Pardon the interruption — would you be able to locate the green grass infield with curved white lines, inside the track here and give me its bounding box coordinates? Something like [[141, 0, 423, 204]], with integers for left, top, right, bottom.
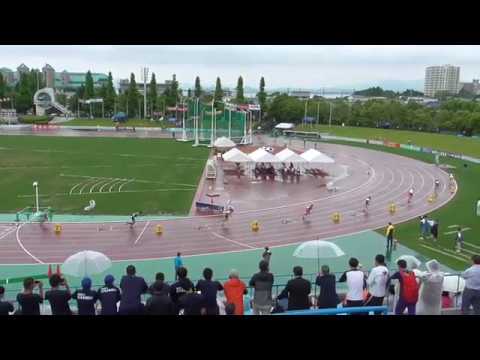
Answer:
[[0, 136, 209, 215]]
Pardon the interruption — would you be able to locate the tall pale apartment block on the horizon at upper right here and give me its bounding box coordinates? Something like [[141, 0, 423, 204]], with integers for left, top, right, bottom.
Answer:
[[424, 65, 460, 98]]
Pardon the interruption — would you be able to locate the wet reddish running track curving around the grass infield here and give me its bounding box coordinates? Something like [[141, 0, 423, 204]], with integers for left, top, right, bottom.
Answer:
[[0, 144, 454, 264]]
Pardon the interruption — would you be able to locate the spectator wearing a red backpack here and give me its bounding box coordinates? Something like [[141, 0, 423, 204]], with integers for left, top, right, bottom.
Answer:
[[387, 260, 420, 315]]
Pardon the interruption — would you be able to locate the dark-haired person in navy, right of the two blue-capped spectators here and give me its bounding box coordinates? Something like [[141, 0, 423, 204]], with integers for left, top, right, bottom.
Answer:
[[119, 265, 148, 315]]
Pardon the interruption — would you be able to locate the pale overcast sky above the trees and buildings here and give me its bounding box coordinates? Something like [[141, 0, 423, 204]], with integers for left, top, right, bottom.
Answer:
[[0, 45, 480, 88]]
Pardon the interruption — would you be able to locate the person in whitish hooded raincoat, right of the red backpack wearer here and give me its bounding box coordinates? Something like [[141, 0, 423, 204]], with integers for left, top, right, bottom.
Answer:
[[416, 260, 444, 315]]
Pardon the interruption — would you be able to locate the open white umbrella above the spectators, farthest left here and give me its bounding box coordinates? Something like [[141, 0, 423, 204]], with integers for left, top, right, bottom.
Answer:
[[62, 250, 112, 277]]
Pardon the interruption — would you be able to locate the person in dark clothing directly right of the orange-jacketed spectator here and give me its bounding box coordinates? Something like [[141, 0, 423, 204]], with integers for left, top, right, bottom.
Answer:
[[249, 260, 274, 315]]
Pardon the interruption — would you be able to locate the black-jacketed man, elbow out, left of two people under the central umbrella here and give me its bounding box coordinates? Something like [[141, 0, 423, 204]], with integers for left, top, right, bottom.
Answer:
[[277, 266, 312, 310]]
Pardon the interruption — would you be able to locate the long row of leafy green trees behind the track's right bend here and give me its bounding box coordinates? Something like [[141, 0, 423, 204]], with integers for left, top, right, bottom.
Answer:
[[264, 94, 480, 132]]
